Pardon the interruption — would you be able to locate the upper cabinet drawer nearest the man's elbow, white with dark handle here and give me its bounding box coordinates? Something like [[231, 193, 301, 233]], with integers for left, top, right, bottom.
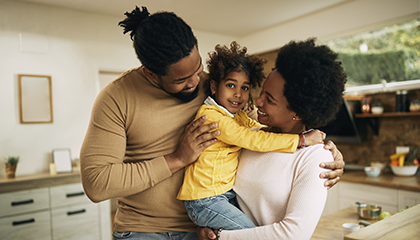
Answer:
[[50, 183, 90, 208]]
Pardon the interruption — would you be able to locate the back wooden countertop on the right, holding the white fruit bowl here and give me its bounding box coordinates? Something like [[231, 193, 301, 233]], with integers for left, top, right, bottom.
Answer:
[[341, 170, 420, 192]]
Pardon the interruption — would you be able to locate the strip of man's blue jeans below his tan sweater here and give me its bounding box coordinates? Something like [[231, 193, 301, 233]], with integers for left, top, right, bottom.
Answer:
[[112, 231, 198, 240]]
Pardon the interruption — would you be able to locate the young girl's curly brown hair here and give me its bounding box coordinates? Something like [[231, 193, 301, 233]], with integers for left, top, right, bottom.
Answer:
[[204, 41, 267, 109]]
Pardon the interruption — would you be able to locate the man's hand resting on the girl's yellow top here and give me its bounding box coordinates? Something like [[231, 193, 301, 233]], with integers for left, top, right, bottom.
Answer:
[[165, 116, 220, 173]]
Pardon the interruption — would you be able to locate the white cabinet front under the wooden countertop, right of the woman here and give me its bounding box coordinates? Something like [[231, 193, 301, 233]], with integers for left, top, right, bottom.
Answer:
[[339, 182, 398, 206]]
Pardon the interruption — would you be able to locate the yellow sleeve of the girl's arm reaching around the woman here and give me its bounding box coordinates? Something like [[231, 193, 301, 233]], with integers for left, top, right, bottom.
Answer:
[[201, 107, 299, 152]]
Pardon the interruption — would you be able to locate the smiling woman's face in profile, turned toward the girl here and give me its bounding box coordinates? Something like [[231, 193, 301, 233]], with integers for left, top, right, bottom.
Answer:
[[255, 70, 302, 133]]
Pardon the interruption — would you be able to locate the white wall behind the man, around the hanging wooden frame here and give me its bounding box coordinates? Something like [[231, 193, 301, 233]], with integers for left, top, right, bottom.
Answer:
[[0, 1, 235, 177]]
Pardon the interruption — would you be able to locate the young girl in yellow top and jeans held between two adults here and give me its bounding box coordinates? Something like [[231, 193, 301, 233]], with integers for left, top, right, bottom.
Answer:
[[177, 42, 325, 230]]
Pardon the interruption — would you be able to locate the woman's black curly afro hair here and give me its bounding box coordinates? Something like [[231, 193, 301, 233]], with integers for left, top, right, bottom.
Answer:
[[275, 38, 347, 127]]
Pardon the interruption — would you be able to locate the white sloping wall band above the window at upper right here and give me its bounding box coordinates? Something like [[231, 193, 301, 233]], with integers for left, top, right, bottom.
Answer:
[[240, 0, 420, 53]]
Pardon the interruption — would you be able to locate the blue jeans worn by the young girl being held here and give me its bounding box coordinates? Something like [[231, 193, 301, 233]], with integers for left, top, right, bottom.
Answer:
[[184, 190, 255, 230]]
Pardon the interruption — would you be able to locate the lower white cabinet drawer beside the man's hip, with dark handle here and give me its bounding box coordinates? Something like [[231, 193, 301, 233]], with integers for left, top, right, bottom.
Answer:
[[52, 203, 100, 240]]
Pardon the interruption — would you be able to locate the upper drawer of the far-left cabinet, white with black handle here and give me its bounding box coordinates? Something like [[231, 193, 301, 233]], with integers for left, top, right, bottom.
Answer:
[[0, 188, 50, 217]]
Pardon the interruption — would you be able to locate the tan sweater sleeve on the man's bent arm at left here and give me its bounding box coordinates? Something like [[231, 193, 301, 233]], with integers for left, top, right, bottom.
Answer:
[[80, 86, 172, 202]]
